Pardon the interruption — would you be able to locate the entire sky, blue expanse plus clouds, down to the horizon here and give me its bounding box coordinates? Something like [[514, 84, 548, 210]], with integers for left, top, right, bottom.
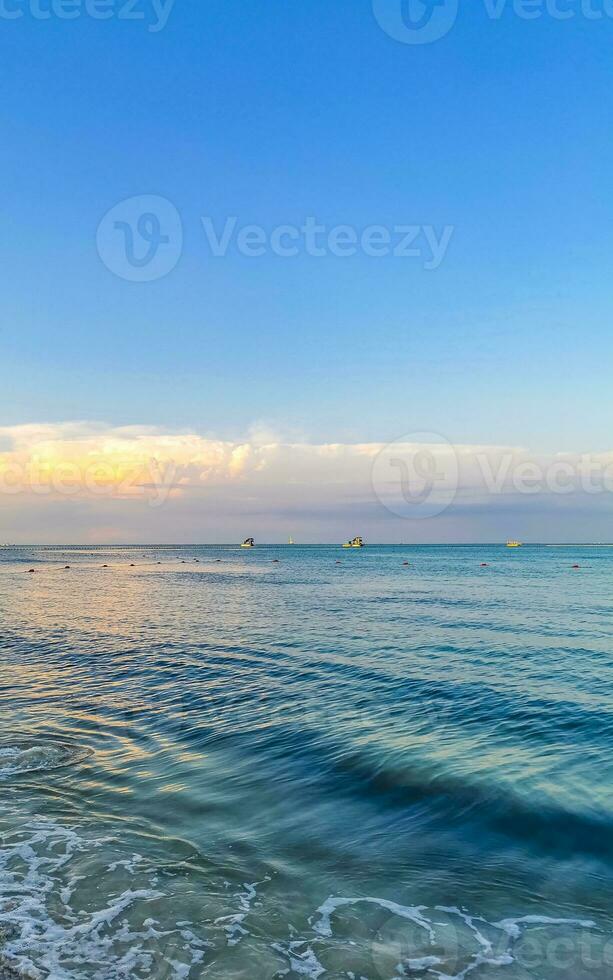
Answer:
[[0, 0, 613, 542]]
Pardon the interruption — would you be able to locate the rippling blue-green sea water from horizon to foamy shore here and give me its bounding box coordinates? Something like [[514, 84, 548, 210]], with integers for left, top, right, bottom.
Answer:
[[0, 546, 613, 980]]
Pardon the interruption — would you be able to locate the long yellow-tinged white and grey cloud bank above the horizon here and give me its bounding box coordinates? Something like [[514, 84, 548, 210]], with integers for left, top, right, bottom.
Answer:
[[0, 421, 613, 544]]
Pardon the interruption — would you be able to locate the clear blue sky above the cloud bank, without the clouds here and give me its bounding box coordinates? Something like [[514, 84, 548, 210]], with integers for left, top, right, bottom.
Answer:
[[0, 0, 613, 451]]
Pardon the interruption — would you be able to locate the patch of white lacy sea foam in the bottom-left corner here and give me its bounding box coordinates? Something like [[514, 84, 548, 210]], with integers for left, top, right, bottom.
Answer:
[[0, 818, 209, 980]]
